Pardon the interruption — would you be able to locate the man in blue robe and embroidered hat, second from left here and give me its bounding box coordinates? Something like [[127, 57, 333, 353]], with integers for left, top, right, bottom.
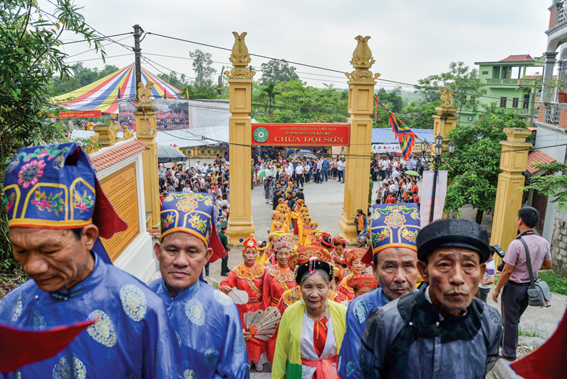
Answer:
[[149, 193, 250, 379]]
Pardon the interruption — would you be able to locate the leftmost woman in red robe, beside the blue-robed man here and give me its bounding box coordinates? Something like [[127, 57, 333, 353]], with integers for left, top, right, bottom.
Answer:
[[219, 234, 266, 371]]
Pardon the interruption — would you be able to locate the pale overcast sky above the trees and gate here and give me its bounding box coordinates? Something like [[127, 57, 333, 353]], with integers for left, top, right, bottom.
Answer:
[[51, 0, 551, 89]]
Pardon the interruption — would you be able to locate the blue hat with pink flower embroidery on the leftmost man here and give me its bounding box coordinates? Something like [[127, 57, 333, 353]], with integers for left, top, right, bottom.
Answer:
[[4, 142, 128, 262]]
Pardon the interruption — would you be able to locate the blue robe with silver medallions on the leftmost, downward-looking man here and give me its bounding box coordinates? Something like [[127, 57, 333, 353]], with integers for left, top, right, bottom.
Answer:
[[0, 254, 179, 379]]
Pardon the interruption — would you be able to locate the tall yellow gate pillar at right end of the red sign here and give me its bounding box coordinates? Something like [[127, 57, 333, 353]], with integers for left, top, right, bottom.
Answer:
[[339, 36, 380, 243]]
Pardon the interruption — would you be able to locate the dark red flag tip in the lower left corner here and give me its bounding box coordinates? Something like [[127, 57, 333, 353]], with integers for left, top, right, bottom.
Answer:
[[0, 319, 98, 372]]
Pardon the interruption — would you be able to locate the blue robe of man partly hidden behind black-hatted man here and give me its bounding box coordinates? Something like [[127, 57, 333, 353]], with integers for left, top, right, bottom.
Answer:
[[339, 287, 388, 379]]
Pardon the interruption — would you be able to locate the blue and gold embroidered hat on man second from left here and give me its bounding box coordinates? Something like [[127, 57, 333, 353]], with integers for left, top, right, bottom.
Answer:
[[161, 192, 227, 262]]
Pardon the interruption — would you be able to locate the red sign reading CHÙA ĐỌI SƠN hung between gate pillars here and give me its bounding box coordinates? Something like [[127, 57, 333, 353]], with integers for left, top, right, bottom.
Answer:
[[252, 123, 350, 146]]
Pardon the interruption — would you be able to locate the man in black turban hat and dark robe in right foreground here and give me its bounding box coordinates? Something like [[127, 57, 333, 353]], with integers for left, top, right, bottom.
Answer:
[[358, 219, 502, 379]]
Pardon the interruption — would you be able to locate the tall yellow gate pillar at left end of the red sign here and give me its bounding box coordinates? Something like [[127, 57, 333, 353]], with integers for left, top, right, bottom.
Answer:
[[225, 32, 255, 245]]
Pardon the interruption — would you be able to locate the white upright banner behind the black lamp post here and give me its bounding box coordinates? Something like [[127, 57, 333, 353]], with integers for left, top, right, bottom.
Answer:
[[419, 170, 447, 228]]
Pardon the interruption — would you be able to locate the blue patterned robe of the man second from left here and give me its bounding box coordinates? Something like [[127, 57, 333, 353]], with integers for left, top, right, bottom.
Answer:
[[149, 279, 250, 379]]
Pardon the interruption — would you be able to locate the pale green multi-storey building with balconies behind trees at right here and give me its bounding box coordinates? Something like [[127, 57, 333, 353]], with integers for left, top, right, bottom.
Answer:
[[458, 54, 544, 124]]
